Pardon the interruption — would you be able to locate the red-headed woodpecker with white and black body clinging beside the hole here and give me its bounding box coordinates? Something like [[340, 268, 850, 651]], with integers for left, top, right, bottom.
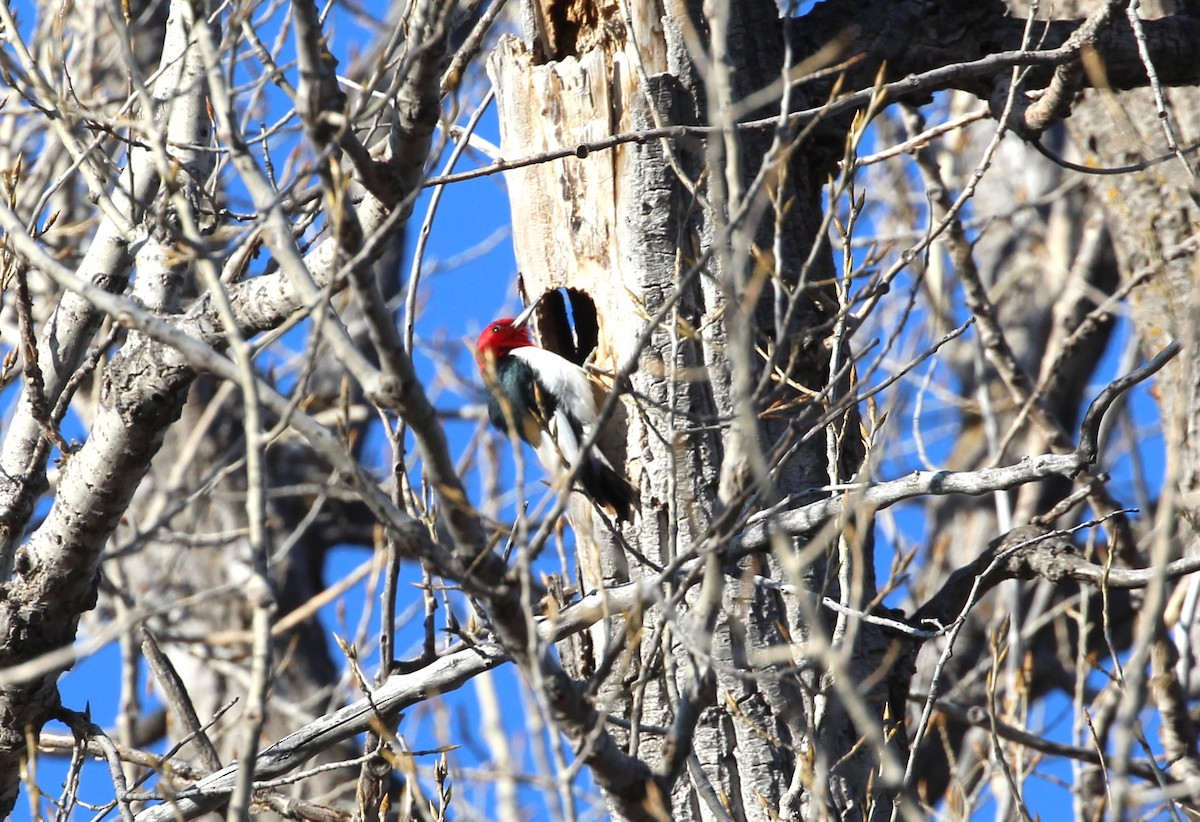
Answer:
[[475, 301, 637, 521]]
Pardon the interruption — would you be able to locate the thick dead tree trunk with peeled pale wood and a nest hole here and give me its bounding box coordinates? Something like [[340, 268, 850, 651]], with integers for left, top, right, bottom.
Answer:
[[491, 2, 895, 820]]
